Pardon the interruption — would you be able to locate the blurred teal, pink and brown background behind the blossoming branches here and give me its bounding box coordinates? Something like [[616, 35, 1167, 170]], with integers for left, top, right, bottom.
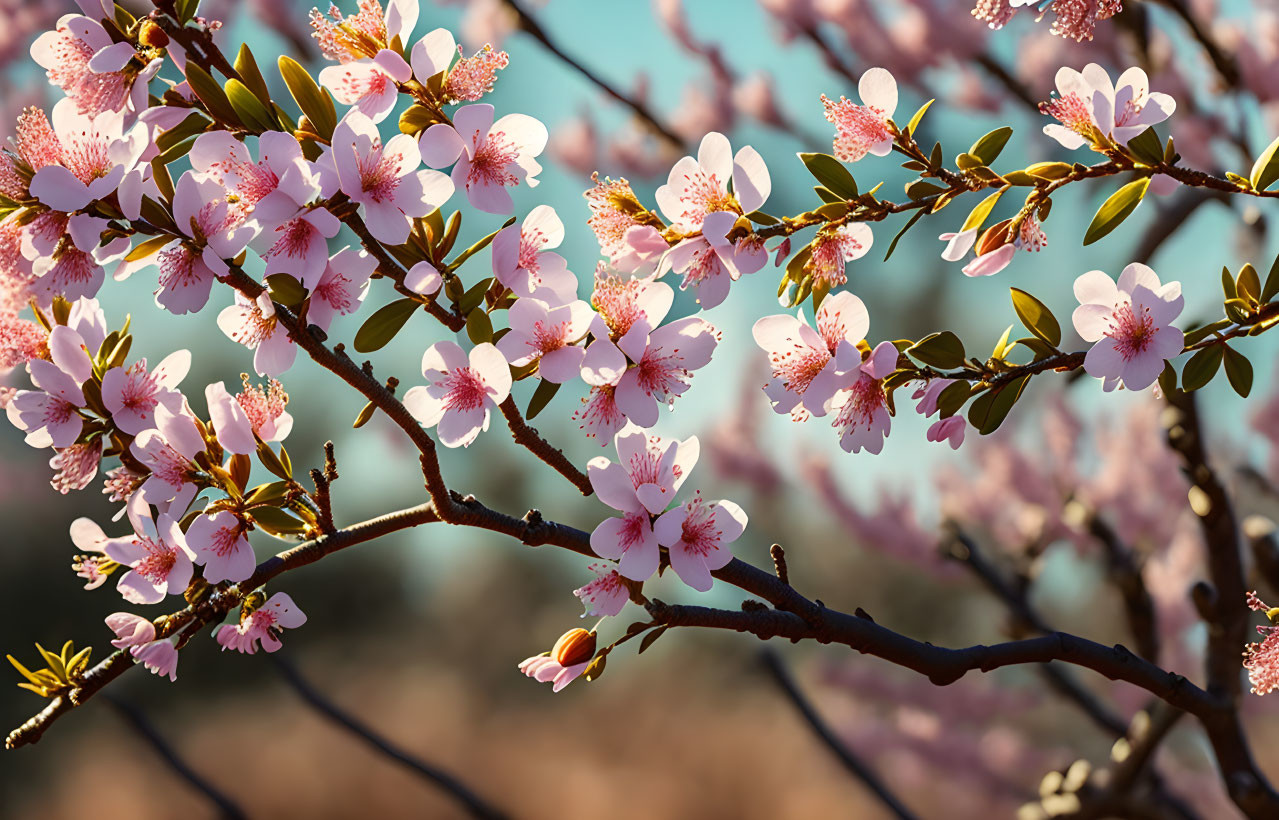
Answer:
[[0, 0, 1279, 819]]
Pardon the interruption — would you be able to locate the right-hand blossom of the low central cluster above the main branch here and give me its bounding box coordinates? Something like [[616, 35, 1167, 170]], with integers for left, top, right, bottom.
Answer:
[[652, 495, 746, 592]]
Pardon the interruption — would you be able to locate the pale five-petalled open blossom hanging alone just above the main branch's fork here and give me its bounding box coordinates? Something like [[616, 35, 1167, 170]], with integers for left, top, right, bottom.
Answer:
[[404, 342, 510, 446]]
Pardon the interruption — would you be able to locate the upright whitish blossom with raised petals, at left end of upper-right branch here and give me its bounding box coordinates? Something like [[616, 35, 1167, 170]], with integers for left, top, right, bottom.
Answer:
[[654, 132, 773, 232]]
